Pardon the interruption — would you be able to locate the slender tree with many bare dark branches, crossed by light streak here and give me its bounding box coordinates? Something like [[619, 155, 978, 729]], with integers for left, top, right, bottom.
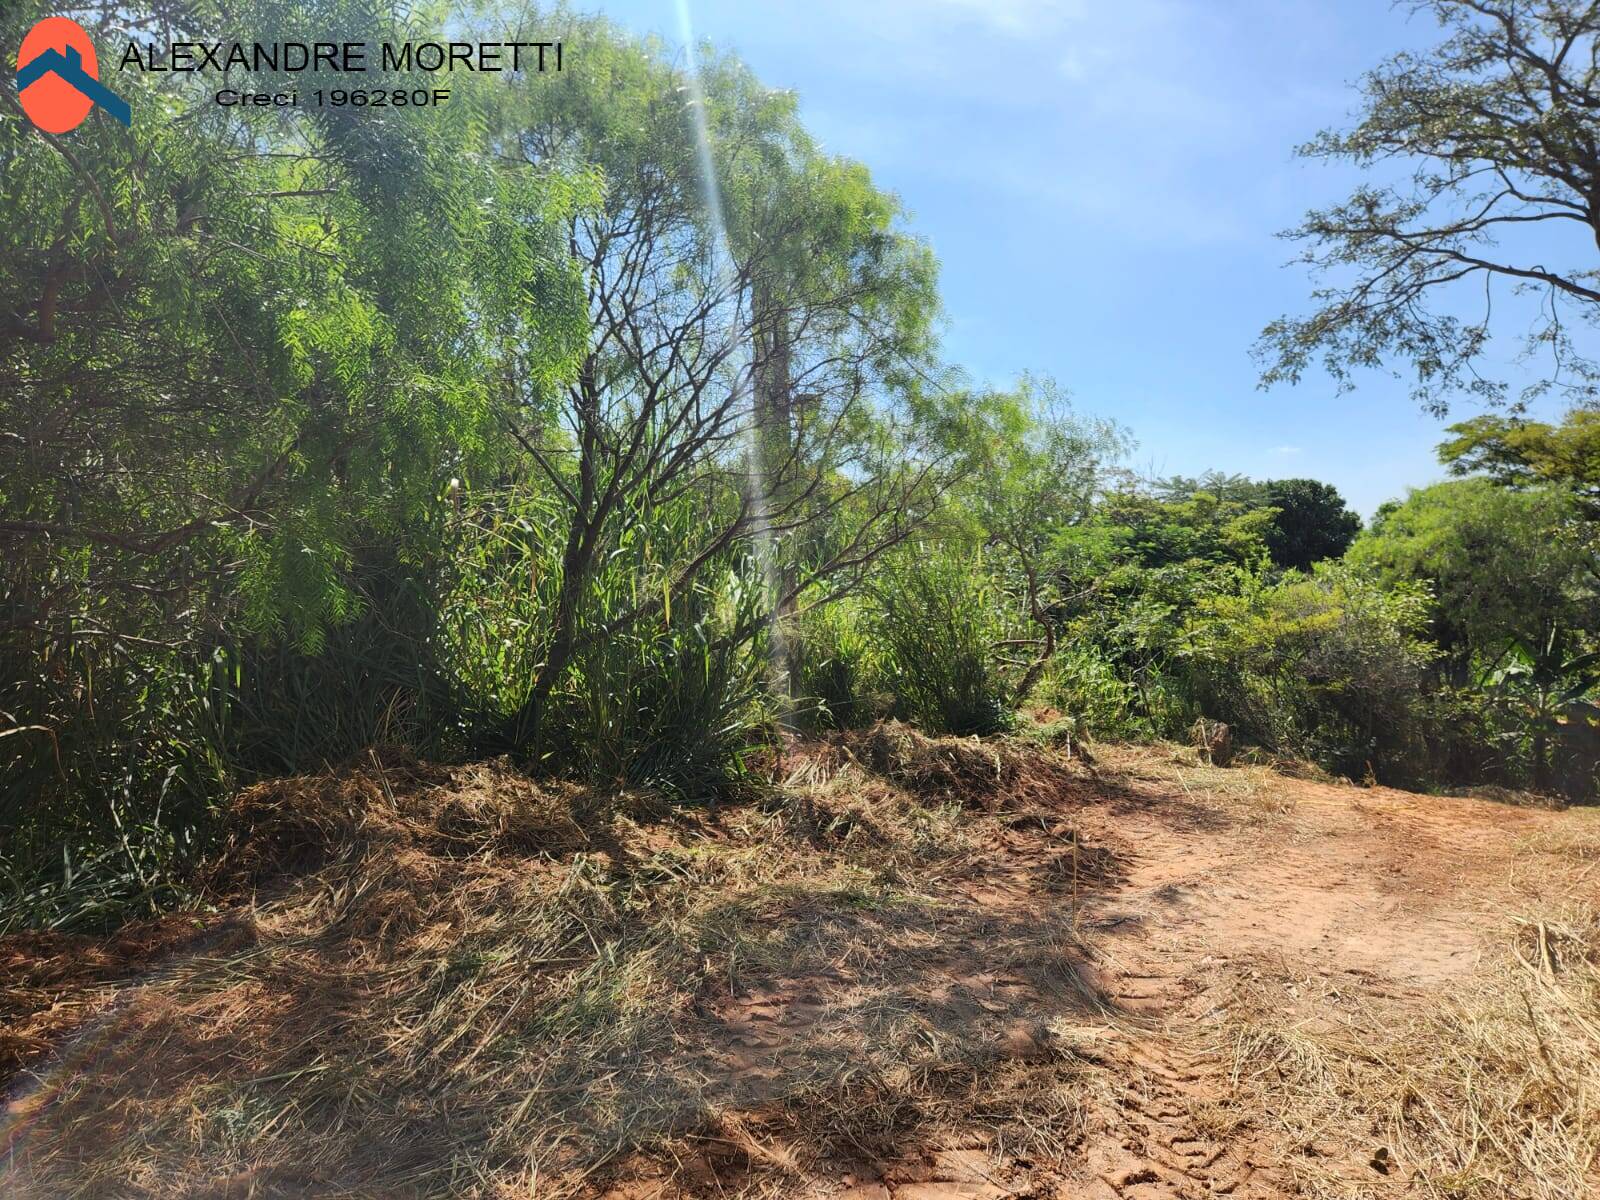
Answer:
[[483, 19, 946, 755]]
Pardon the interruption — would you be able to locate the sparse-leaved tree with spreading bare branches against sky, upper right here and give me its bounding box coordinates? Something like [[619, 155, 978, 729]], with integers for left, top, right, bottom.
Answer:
[[1256, 0, 1600, 411]]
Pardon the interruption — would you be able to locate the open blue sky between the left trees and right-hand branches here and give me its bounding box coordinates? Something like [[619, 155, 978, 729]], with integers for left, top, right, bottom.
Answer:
[[585, 0, 1561, 517]]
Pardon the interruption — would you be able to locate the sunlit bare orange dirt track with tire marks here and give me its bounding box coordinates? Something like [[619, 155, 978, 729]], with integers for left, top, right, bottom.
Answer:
[[1049, 755, 1561, 1200]]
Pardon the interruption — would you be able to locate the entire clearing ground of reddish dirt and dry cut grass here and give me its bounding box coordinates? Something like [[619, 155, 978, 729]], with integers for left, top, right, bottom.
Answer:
[[0, 726, 1600, 1200]]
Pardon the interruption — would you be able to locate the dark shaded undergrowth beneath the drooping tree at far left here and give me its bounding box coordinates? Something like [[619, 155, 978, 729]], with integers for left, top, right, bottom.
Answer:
[[0, 566, 448, 930]]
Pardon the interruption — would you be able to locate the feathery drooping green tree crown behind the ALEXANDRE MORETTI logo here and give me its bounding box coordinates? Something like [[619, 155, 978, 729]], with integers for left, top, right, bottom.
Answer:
[[0, 0, 582, 652]]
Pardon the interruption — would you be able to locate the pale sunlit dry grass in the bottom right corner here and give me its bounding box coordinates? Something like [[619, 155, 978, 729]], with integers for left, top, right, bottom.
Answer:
[[1229, 906, 1600, 1200]]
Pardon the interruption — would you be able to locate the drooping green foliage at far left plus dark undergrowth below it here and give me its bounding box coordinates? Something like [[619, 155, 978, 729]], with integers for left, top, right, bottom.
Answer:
[[0, 0, 594, 912]]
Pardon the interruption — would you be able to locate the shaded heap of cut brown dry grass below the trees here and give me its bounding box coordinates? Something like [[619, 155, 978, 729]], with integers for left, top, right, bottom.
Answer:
[[0, 728, 1091, 1197]]
